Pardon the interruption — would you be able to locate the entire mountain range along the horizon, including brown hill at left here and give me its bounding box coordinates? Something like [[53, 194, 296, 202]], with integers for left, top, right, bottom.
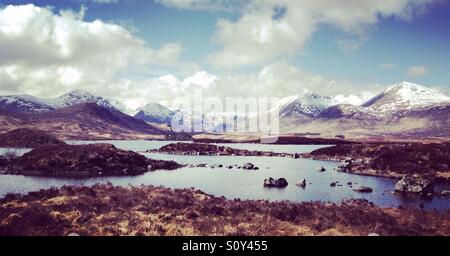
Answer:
[[0, 82, 450, 138]]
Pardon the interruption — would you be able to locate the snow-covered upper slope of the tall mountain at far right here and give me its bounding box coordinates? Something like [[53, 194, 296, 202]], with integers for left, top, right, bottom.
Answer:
[[362, 82, 450, 115]]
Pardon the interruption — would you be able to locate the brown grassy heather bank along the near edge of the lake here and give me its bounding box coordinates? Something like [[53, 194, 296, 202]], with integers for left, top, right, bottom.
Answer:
[[0, 185, 450, 236]]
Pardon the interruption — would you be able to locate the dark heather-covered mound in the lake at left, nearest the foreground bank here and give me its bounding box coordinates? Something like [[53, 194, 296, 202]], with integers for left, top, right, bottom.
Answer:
[[0, 144, 181, 178]]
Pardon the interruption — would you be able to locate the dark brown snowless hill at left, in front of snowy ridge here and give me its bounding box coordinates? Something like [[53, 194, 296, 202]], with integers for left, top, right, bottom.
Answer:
[[0, 103, 167, 139]]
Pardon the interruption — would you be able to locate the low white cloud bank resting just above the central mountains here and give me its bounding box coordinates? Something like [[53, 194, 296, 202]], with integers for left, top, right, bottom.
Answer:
[[109, 61, 380, 112]]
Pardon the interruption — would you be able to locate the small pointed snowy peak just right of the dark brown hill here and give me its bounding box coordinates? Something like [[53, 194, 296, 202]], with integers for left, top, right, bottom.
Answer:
[[134, 103, 175, 124]]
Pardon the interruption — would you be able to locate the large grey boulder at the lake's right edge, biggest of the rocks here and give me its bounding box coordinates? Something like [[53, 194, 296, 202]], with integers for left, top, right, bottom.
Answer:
[[395, 175, 434, 195]]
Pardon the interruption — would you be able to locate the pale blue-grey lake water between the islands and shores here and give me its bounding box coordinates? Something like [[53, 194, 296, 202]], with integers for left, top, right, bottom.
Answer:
[[0, 141, 450, 210]]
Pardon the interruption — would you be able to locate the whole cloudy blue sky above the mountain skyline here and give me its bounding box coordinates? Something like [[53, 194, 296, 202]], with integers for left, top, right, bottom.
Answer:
[[0, 0, 450, 109]]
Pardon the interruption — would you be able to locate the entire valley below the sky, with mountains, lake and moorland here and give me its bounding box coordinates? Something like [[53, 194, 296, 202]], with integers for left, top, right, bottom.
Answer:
[[0, 82, 450, 235]]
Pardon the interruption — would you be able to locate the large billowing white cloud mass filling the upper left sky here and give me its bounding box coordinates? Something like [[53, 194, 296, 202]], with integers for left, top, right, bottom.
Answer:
[[0, 4, 191, 96]]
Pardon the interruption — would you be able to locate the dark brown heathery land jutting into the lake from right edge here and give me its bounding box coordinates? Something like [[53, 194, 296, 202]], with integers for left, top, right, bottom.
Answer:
[[302, 143, 450, 182]]
